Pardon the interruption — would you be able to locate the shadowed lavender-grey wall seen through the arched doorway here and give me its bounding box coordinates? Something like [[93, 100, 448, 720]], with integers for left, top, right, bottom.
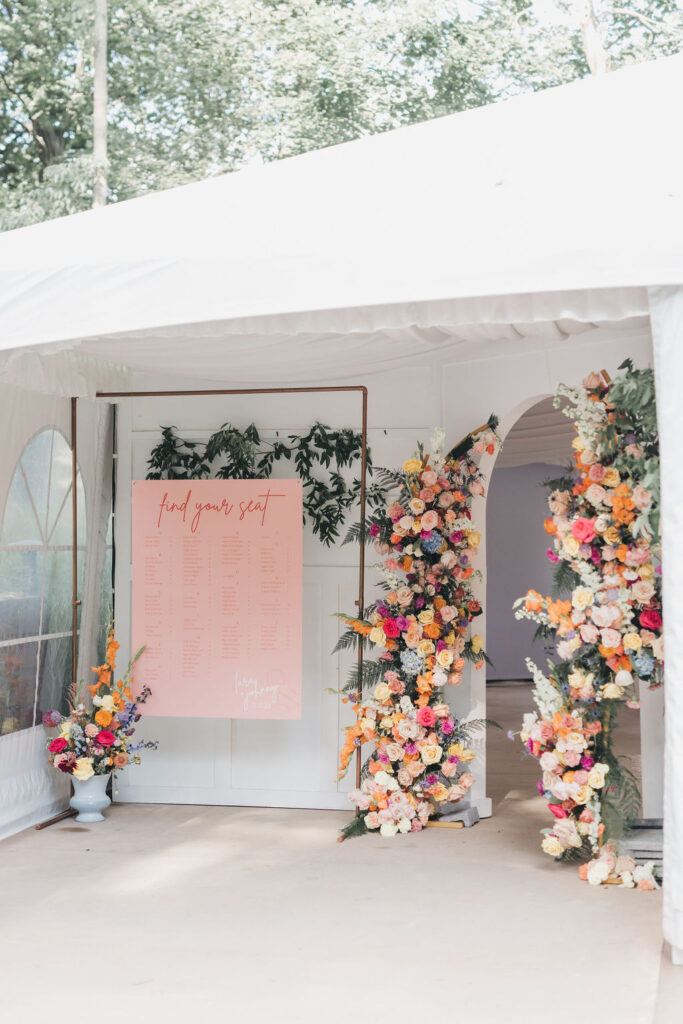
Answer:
[[486, 464, 569, 680]]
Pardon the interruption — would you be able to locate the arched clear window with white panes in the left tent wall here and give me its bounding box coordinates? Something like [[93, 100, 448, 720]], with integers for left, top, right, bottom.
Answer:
[[0, 428, 86, 734]]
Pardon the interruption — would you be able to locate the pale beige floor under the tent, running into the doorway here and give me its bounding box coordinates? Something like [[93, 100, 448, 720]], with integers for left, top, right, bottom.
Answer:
[[0, 684, 683, 1024]]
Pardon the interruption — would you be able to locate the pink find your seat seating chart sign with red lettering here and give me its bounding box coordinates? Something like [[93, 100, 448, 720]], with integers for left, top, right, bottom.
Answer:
[[132, 480, 303, 719]]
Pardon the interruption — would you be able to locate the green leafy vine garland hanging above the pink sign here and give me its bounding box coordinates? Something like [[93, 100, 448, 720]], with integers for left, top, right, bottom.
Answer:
[[146, 422, 386, 547]]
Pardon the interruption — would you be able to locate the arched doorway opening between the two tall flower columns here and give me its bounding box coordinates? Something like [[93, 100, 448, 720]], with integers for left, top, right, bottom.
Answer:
[[486, 396, 656, 827]]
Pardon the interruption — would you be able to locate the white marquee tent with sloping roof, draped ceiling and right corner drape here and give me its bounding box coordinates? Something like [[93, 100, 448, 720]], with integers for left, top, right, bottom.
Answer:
[[0, 49, 683, 956]]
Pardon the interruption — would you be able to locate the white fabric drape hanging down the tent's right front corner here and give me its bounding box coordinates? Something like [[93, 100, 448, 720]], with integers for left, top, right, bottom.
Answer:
[[649, 288, 683, 963]]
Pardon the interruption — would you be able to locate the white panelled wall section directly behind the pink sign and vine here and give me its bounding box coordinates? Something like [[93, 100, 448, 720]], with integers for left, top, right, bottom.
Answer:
[[116, 368, 450, 810]]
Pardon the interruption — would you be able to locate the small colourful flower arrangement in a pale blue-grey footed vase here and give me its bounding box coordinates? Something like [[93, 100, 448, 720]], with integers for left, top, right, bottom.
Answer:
[[43, 628, 158, 821]]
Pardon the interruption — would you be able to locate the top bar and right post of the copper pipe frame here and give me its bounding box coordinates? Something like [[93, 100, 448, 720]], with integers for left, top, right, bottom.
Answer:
[[96, 384, 368, 790]]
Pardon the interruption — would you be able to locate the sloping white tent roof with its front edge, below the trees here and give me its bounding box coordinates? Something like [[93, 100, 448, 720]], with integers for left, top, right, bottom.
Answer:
[[0, 55, 683, 380]]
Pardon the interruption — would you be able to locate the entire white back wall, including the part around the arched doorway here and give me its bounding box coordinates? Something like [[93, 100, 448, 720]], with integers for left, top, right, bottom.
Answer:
[[111, 315, 661, 814]]
